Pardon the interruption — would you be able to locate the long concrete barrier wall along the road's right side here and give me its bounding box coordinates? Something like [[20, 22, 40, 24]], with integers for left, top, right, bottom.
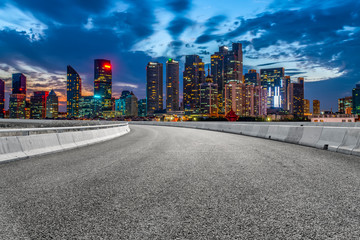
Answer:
[[130, 121, 360, 156]]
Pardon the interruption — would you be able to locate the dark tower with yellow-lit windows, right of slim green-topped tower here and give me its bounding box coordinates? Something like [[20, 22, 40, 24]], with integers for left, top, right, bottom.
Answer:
[[183, 55, 205, 115]]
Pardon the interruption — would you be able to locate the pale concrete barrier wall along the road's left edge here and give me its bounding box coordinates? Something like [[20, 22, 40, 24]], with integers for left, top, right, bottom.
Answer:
[[0, 123, 130, 162]]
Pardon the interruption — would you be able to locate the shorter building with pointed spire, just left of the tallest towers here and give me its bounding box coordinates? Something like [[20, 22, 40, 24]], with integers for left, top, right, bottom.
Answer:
[[200, 70, 218, 116]]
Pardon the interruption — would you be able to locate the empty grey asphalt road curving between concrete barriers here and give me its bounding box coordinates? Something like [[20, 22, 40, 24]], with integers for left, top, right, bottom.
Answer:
[[0, 126, 360, 240]]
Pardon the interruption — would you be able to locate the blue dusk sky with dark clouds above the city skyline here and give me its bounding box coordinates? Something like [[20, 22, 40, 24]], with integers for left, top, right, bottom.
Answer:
[[0, 0, 360, 111]]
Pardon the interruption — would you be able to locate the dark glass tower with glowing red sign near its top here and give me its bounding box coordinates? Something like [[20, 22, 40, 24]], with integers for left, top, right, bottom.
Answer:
[[94, 59, 112, 112]]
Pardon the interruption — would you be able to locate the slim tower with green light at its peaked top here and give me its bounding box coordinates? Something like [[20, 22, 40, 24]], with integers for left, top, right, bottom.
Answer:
[[166, 58, 179, 112]]
